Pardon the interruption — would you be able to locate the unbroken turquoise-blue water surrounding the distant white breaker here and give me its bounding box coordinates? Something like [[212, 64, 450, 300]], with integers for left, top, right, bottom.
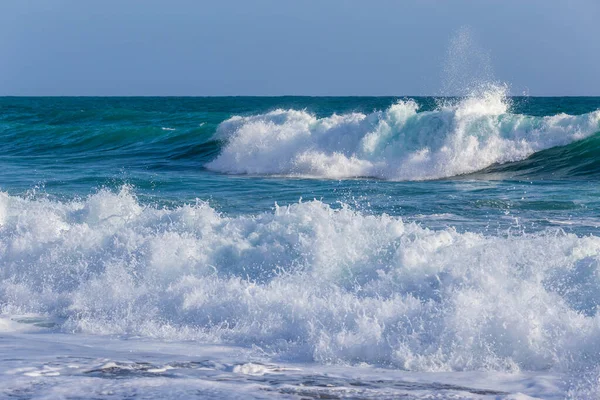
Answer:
[[0, 97, 600, 234]]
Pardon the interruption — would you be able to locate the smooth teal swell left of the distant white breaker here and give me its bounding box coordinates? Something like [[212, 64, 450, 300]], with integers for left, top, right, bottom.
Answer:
[[0, 100, 222, 167]]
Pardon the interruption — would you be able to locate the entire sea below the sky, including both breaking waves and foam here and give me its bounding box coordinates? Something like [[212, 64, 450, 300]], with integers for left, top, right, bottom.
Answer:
[[0, 92, 600, 399]]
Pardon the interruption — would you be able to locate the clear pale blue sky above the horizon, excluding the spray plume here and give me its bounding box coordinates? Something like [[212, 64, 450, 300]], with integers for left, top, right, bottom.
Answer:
[[0, 0, 600, 96]]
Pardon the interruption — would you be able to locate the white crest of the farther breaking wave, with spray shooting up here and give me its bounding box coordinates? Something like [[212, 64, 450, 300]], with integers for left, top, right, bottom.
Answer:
[[206, 88, 600, 180]]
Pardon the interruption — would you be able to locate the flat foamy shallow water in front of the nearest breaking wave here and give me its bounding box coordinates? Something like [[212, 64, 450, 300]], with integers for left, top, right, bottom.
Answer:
[[0, 332, 568, 400]]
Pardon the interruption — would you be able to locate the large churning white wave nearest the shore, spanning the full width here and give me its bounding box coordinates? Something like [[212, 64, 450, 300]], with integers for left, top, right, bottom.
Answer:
[[0, 188, 600, 372]]
